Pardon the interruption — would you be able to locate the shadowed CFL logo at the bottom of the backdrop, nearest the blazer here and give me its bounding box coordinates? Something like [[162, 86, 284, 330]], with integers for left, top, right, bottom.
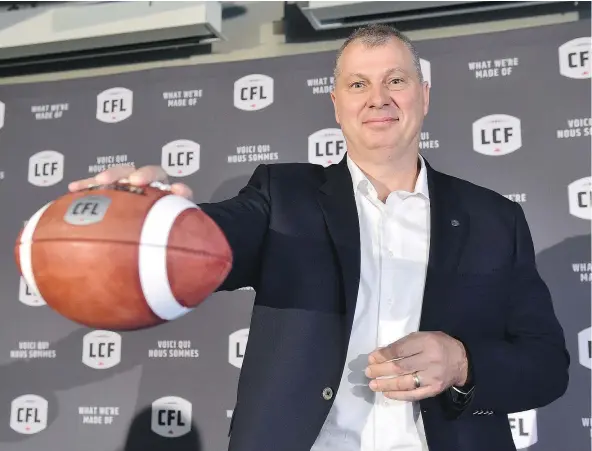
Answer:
[[152, 396, 192, 438]]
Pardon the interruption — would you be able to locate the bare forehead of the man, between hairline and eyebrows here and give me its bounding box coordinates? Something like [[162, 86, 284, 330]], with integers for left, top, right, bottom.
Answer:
[[339, 38, 414, 75]]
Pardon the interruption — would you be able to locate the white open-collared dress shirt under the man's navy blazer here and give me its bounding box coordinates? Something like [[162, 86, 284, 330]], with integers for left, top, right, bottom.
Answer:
[[311, 154, 430, 451]]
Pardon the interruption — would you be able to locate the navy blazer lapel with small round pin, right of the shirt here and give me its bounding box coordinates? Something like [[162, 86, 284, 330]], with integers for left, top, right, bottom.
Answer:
[[419, 161, 469, 331]]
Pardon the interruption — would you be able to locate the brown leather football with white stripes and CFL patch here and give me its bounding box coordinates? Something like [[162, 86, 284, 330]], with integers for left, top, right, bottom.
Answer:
[[15, 183, 232, 330]]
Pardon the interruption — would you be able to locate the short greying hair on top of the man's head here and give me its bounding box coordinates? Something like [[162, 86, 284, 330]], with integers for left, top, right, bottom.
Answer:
[[333, 24, 423, 82]]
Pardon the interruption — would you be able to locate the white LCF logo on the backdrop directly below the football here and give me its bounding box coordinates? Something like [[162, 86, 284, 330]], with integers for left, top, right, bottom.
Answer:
[[82, 330, 121, 370]]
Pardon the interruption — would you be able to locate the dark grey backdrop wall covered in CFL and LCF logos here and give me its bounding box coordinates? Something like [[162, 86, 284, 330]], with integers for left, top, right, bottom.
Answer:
[[0, 21, 592, 451]]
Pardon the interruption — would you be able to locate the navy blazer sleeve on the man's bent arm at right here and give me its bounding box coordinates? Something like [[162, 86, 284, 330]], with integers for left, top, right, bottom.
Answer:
[[448, 203, 570, 416]]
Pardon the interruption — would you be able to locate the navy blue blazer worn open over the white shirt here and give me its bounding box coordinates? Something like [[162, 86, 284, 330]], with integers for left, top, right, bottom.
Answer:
[[200, 158, 569, 451]]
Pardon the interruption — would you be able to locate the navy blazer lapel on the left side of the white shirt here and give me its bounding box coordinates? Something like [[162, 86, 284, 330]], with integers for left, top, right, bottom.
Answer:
[[318, 157, 360, 343]]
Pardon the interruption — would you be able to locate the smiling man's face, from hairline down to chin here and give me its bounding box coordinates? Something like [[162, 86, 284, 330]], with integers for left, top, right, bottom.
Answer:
[[331, 39, 429, 159]]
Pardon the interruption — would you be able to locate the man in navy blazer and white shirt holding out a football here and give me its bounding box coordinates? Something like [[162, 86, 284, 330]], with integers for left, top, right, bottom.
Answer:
[[71, 25, 569, 451]]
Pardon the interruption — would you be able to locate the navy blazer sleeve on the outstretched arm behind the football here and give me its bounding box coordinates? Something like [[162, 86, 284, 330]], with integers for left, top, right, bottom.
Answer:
[[198, 165, 271, 291]]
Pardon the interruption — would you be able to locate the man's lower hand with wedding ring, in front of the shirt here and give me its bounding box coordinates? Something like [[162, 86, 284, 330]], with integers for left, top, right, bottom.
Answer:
[[366, 332, 468, 401]]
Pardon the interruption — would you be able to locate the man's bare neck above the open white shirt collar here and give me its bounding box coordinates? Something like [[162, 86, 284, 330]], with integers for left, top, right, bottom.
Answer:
[[350, 152, 420, 202]]
